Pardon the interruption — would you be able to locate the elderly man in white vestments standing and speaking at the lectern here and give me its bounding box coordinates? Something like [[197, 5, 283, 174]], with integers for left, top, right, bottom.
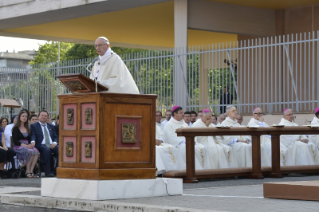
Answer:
[[90, 37, 140, 94]]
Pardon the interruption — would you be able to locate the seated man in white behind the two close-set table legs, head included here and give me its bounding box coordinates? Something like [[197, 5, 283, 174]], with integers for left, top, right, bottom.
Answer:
[[248, 107, 288, 166]]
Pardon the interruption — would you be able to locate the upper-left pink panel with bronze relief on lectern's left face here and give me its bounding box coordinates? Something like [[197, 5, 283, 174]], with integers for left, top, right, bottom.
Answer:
[[63, 104, 77, 130]]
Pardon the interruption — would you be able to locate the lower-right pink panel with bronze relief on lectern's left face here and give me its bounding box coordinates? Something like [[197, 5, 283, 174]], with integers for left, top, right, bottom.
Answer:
[[81, 136, 96, 163]]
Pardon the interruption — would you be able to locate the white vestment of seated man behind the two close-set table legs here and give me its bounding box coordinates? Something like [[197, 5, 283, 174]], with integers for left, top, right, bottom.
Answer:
[[248, 118, 288, 166]]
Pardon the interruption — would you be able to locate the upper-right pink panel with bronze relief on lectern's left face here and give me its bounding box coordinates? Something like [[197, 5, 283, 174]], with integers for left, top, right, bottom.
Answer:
[[81, 103, 96, 130]]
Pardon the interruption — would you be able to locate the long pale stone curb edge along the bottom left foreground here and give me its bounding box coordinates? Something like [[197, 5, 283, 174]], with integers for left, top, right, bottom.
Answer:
[[0, 194, 216, 212]]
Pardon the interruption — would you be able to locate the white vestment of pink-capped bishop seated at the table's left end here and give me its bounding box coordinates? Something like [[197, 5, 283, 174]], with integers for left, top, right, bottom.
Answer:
[[164, 117, 211, 170]]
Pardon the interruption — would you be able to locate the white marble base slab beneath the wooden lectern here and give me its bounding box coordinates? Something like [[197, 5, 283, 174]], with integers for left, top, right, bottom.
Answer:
[[41, 178, 183, 200]]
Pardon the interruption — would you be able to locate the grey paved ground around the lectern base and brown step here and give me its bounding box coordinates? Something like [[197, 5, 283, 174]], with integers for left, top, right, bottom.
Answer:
[[0, 175, 319, 212]]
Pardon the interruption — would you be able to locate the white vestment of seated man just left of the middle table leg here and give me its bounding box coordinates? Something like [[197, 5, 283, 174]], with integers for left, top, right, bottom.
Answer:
[[219, 117, 252, 167]]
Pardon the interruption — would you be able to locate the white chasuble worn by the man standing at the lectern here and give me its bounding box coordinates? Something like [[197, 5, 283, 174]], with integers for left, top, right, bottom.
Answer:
[[90, 51, 140, 94]]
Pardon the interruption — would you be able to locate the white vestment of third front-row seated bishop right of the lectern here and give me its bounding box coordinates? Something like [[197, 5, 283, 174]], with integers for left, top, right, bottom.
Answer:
[[192, 119, 238, 169]]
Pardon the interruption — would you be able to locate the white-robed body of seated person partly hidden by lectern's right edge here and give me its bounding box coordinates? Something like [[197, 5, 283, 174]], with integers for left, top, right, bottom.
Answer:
[[156, 125, 186, 174]]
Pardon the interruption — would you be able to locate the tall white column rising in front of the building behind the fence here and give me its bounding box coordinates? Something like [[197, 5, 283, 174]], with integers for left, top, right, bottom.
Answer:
[[174, 0, 187, 107]]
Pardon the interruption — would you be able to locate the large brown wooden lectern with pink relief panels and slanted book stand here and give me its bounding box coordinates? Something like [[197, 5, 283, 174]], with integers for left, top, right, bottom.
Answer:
[[57, 74, 157, 180]]
